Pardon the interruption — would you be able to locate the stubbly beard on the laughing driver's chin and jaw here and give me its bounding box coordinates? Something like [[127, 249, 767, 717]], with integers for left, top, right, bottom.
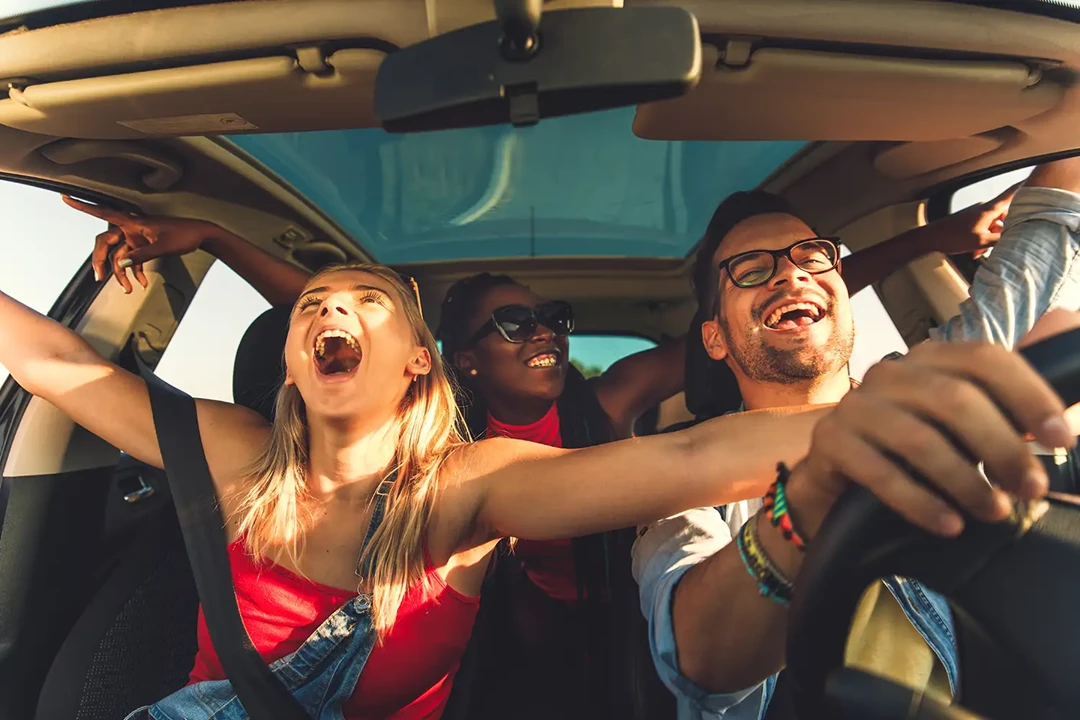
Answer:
[[717, 303, 855, 385]]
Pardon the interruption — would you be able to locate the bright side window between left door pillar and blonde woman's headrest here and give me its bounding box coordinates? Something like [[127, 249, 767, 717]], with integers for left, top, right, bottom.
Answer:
[[154, 262, 270, 403]]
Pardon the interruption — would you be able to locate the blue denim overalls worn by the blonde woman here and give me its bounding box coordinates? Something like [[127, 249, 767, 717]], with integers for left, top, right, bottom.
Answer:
[[124, 481, 391, 720]]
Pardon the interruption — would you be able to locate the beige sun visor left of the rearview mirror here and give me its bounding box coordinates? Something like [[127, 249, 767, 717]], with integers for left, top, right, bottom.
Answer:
[[0, 49, 386, 139]]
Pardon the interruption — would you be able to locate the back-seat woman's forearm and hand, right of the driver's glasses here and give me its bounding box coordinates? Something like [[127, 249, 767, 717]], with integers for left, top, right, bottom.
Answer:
[[843, 188, 1016, 295]]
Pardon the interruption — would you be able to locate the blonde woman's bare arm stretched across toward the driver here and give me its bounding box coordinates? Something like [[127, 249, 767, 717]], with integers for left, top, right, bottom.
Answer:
[[458, 406, 827, 540]]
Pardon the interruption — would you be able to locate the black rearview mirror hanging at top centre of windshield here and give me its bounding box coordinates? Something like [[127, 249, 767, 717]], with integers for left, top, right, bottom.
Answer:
[[375, 0, 701, 133]]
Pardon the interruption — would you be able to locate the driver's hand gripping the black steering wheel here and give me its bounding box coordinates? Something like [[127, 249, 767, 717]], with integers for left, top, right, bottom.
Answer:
[[788, 342, 1075, 538]]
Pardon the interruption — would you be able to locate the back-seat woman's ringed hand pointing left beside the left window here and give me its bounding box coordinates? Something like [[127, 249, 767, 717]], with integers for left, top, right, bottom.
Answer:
[[64, 195, 221, 293]]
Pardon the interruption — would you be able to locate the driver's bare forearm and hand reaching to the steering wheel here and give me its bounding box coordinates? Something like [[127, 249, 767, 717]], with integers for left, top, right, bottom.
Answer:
[[635, 338, 1080, 696]]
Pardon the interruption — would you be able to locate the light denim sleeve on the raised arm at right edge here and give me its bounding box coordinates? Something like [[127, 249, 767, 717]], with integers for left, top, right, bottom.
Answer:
[[930, 188, 1080, 349]]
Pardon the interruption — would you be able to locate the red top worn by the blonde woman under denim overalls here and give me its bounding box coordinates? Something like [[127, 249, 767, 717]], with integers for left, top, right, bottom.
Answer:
[[190, 540, 480, 720]]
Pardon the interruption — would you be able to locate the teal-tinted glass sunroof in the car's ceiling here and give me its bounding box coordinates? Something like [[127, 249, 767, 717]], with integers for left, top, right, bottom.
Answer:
[[225, 108, 806, 263]]
